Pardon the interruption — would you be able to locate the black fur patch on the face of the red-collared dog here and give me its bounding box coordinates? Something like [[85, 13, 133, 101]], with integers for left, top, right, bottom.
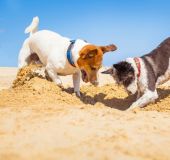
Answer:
[[113, 61, 135, 87]]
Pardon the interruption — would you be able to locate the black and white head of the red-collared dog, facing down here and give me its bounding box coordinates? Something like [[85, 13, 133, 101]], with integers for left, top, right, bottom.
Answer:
[[102, 61, 137, 94]]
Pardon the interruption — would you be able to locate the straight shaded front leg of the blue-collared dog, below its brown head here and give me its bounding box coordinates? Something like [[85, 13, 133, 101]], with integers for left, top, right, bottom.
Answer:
[[73, 72, 81, 97]]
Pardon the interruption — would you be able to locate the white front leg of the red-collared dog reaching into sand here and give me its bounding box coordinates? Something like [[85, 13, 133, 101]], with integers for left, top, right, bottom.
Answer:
[[127, 90, 158, 110]]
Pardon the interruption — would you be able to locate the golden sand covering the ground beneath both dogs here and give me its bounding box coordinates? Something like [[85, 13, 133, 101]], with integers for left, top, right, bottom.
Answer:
[[0, 66, 170, 160]]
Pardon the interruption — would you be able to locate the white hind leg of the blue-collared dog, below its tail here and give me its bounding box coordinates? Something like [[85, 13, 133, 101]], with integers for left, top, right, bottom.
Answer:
[[18, 40, 31, 68]]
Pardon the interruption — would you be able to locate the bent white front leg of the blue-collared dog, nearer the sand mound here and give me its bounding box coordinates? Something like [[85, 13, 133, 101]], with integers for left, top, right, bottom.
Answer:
[[46, 65, 63, 87]]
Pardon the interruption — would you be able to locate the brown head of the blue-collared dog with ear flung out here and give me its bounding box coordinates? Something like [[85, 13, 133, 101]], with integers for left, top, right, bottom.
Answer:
[[77, 45, 117, 85]]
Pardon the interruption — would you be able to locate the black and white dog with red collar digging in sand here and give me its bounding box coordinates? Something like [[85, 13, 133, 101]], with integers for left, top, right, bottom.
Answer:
[[102, 38, 170, 110]]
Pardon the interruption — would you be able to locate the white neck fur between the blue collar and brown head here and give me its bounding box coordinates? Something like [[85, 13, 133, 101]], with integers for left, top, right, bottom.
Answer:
[[72, 39, 89, 68]]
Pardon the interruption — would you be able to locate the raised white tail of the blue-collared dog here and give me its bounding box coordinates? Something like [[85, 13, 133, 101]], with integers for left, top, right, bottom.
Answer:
[[25, 17, 39, 36]]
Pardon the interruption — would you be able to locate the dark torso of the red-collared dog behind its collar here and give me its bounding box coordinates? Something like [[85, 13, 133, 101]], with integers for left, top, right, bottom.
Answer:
[[141, 38, 170, 84]]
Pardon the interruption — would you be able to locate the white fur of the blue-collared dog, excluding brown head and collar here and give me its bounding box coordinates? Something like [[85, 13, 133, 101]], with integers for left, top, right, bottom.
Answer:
[[18, 17, 88, 95]]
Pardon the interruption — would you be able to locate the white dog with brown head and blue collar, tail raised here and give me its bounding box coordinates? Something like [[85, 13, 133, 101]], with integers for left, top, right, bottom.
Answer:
[[18, 17, 117, 96]]
